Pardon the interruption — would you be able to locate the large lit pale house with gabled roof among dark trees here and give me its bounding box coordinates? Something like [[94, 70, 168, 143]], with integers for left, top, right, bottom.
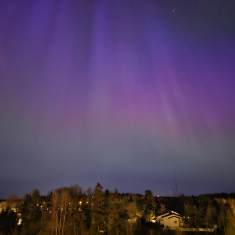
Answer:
[[156, 211, 184, 230]]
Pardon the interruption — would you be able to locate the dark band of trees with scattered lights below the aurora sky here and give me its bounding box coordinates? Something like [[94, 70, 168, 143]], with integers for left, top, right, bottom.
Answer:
[[0, 183, 235, 235]]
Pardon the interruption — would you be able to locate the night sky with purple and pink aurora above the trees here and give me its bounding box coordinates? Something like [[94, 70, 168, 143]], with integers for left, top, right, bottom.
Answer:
[[0, 0, 235, 197]]
